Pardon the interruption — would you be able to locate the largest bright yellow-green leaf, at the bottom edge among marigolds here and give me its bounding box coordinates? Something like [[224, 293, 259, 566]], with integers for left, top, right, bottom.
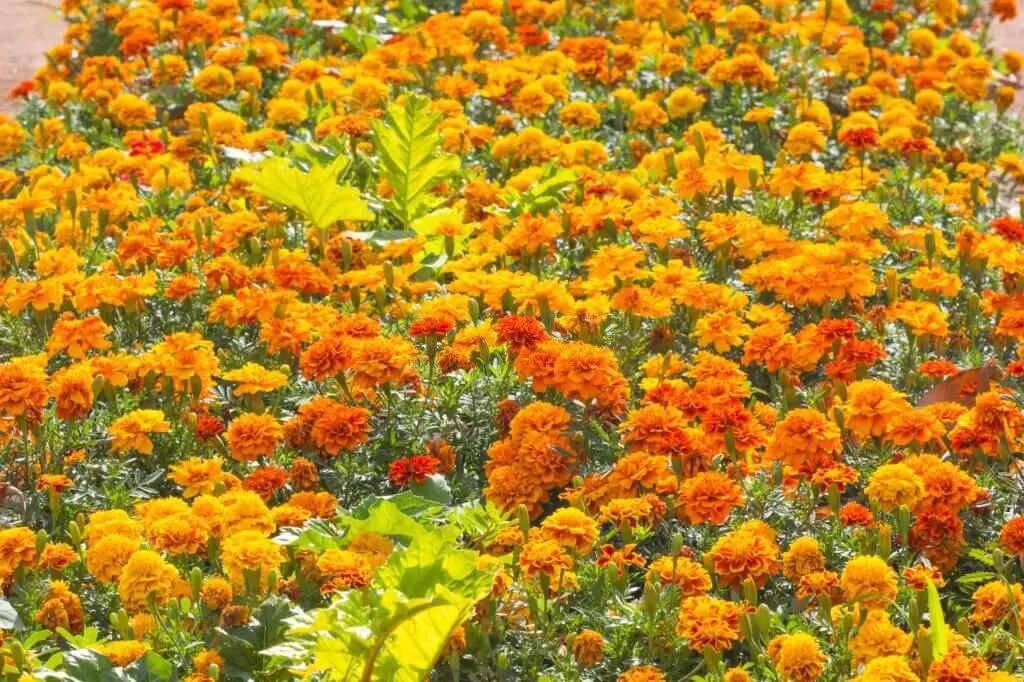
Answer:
[[263, 502, 494, 682]]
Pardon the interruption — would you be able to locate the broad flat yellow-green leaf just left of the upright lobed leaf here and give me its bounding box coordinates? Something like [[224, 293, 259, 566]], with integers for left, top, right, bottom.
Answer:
[[236, 157, 374, 229]]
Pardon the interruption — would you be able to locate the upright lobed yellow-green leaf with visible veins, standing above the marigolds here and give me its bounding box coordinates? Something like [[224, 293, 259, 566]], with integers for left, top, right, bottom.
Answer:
[[373, 96, 462, 229]]
